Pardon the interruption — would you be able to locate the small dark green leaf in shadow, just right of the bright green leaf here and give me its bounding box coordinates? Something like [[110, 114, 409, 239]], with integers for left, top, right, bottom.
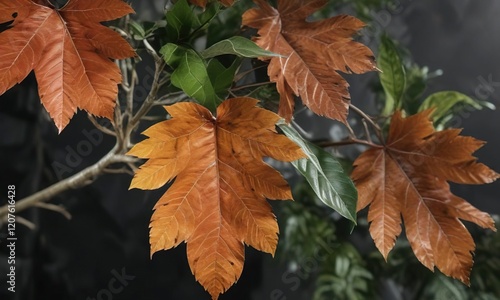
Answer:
[[207, 58, 241, 99]]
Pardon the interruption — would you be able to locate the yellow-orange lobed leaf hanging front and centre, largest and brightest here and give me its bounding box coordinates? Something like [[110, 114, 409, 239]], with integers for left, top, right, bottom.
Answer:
[[129, 98, 304, 299]]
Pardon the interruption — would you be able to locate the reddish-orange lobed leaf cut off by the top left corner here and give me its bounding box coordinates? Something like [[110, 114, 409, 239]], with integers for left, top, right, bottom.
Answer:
[[0, 0, 135, 132]]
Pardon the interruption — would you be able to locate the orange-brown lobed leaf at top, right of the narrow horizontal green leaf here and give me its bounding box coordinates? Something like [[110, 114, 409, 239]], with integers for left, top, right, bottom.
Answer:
[[243, 0, 377, 123]]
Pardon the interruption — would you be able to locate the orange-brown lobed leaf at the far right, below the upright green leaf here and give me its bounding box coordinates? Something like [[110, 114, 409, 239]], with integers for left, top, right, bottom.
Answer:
[[352, 110, 499, 284]]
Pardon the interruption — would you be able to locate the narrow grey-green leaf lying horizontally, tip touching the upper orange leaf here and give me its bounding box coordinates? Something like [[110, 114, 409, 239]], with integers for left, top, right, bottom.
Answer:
[[201, 36, 279, 58]]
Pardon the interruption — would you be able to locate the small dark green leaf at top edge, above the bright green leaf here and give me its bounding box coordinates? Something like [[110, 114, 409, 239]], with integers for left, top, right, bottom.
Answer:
[[166, 0, 197, 42]]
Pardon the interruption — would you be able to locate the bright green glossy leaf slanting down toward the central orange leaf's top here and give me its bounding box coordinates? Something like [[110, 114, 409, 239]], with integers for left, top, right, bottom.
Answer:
[[160, 43, 222, 112]]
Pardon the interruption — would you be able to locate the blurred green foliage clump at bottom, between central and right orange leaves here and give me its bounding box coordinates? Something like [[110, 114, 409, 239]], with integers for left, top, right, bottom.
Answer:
[[279, 183, 375, 300]]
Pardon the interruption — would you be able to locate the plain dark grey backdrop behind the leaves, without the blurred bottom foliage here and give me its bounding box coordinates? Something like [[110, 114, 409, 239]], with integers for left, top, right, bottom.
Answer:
[[0, 0, 500, 300]]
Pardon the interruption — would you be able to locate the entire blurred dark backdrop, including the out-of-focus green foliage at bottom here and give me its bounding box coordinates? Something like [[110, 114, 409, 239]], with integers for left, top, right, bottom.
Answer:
[[0, 0, 500, 300]]
